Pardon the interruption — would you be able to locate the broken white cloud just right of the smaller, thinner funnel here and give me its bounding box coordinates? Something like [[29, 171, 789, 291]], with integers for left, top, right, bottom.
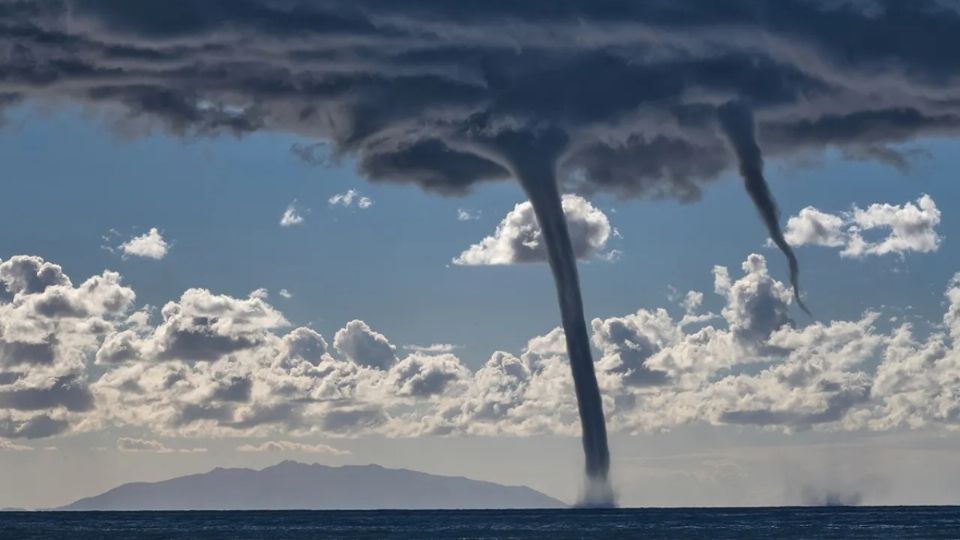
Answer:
[[784, 195, 943, 258]]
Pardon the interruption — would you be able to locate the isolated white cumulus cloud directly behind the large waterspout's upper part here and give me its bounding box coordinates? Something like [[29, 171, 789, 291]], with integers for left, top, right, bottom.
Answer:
[[453, 195, 616, 266]]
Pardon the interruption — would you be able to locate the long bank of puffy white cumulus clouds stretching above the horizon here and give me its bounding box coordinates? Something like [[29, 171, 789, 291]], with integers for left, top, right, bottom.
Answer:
[[0, 254, 960, 442]]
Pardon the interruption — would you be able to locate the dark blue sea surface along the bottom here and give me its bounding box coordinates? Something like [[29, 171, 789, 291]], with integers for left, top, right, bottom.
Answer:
[[0, 506, 960, 540]]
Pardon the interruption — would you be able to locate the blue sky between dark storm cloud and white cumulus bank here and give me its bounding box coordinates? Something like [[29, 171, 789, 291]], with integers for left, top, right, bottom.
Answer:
[[0, 102, 960, 366]]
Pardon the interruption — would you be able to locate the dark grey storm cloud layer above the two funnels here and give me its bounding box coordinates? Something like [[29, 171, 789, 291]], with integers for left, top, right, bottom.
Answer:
[[0, 0, 960, 200]]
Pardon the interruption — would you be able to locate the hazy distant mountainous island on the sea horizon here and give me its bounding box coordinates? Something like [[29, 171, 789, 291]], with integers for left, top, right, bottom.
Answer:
[[56, 461, 567, 511]]
